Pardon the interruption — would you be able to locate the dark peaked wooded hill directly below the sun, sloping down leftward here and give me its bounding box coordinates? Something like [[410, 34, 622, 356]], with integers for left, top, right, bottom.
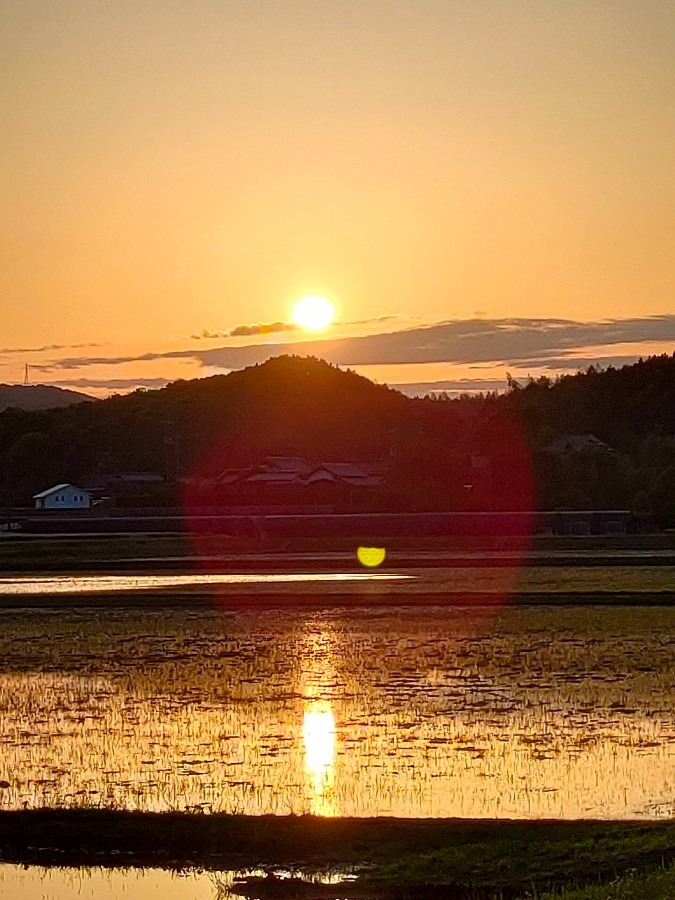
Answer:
[[0, 357, 413, 489]]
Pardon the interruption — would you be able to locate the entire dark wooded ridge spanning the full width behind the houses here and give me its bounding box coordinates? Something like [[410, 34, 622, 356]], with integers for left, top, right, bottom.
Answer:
[[0, 356, 675, 509]]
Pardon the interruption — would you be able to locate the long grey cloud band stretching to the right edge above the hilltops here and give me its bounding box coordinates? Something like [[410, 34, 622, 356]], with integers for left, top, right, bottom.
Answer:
[[31, 315, 675, 372]]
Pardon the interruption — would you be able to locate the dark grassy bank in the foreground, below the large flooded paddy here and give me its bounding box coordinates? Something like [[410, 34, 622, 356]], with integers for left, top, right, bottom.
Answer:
[[0, 809, 675, 900]]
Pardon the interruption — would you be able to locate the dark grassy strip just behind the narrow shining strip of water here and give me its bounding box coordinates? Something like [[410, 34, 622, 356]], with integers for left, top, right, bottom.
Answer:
[[0, 533, 675, 573]]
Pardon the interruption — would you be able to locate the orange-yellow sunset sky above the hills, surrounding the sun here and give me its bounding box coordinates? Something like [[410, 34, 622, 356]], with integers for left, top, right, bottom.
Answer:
[[0, 0, 675, 395]]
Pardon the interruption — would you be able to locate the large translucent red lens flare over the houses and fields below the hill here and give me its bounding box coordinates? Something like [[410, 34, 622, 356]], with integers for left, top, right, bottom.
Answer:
[[183, 403, 535, 613]]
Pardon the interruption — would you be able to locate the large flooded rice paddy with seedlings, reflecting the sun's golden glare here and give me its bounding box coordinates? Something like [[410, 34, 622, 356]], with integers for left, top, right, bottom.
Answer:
[[0, 604, 675, 818]]
